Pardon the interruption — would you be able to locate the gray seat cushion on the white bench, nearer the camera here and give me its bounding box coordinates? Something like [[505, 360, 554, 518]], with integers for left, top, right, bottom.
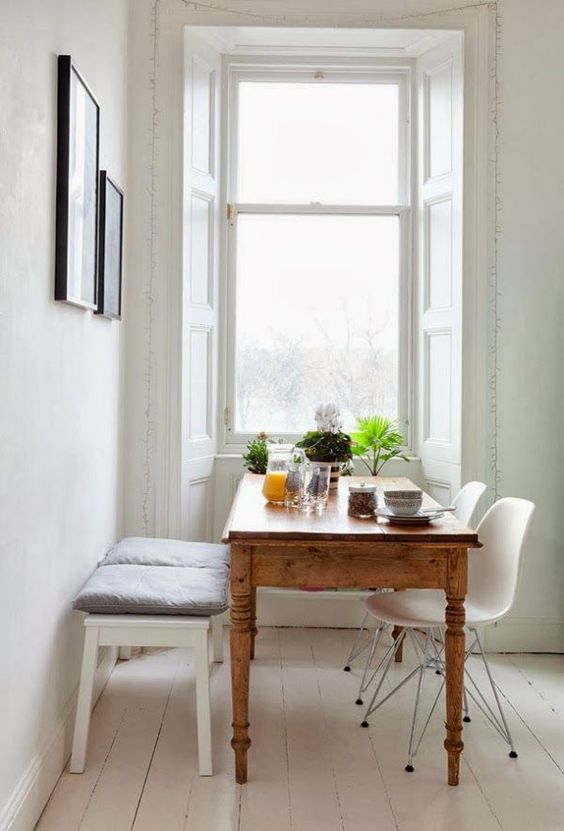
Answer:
[[73, 563, 229, 616]]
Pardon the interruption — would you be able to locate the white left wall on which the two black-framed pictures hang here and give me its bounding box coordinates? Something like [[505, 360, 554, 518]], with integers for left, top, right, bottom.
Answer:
[[0, 0, 127, 828]]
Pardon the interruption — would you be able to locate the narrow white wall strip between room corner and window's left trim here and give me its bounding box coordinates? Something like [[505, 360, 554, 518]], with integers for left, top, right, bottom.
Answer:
[[123, 0, 162, 534]]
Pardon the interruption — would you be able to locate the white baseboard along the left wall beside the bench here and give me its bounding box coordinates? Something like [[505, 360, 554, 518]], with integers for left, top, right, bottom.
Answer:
[[0, 647, 117, 831]]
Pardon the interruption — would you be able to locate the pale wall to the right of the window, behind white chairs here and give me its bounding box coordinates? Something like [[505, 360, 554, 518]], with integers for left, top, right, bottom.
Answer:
[[490, 0, 564, 651]]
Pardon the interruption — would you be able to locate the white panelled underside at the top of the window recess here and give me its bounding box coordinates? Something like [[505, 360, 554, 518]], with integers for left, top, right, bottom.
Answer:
[[197, 26, 451, 57]]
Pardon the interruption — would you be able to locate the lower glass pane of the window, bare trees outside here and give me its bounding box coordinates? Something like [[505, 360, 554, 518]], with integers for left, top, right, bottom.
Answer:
[[235, 214, 399, 433]]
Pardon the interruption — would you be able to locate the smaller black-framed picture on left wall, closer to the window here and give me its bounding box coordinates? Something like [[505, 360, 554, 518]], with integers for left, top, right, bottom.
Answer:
[[96, 170, 123, 320]]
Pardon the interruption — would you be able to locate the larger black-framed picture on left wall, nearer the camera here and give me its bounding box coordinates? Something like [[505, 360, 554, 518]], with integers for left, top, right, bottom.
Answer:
[[55, 55, 100, 309]]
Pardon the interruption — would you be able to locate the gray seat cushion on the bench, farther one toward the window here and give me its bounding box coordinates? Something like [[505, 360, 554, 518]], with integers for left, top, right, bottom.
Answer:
[[100, 537, 230, 573]]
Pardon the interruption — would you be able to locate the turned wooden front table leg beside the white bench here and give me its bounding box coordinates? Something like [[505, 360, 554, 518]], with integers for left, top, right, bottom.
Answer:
[[230, 545, 252, 785]]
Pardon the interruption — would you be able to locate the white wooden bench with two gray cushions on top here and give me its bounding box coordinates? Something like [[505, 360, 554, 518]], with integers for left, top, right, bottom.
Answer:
[[70, 537, 229, 776]]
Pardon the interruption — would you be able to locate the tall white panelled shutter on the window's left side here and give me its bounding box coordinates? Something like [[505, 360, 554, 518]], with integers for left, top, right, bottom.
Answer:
[[181, 30, 221, 540]]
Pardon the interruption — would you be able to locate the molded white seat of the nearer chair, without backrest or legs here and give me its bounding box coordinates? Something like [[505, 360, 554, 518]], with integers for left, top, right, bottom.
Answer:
[[366, 588, 506, 628]]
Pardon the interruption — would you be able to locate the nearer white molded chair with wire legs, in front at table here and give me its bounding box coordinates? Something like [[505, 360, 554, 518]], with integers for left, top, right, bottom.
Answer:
[[356, 497, 535, 772]]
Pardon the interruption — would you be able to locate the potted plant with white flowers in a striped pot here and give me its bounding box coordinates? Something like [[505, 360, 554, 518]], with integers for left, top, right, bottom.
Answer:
[[296, 403, 352, 489]]
